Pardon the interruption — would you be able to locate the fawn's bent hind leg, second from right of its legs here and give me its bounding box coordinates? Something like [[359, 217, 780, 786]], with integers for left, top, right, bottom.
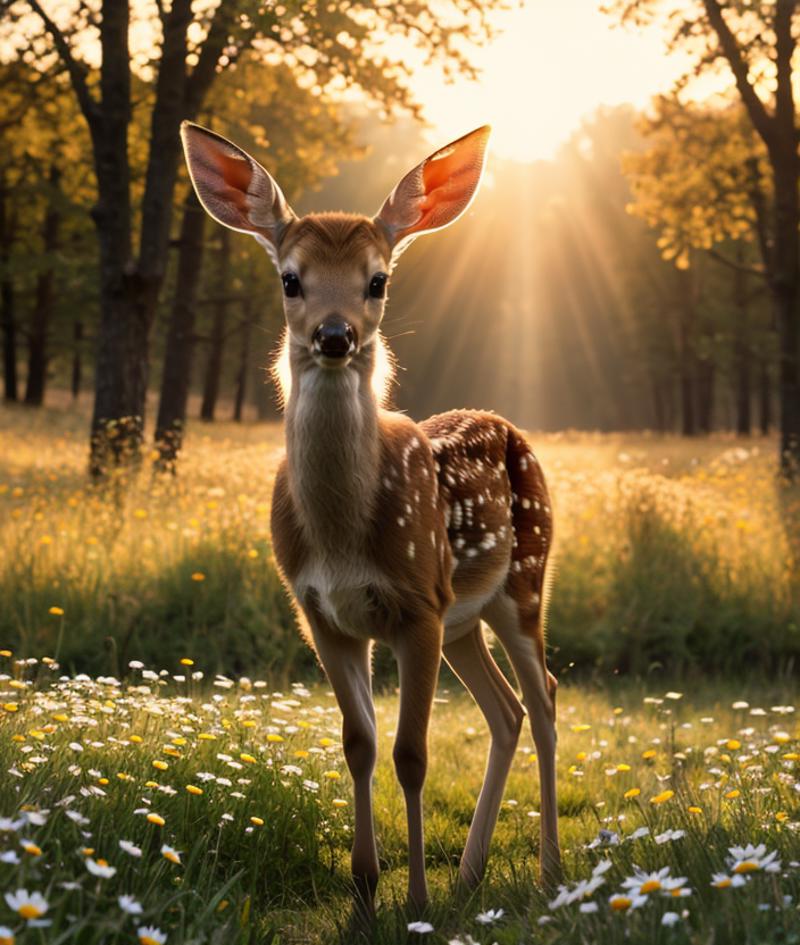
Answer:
[[443, 622, 525, 886]]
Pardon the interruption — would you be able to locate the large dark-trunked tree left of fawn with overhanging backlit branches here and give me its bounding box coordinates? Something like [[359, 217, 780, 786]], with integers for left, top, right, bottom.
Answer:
[[5, 0, 504, 475]]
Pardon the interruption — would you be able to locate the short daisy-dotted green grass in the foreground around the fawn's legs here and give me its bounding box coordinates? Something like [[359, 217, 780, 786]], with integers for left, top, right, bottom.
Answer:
[[0, 658, 800, 945]]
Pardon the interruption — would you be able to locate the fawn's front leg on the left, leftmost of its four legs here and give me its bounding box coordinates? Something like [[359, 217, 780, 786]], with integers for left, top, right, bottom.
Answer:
[[309, 614, 379, 912]]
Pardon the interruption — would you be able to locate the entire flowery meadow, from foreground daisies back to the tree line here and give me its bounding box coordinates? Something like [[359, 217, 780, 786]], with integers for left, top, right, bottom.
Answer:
[[0, 408, 800, 945]]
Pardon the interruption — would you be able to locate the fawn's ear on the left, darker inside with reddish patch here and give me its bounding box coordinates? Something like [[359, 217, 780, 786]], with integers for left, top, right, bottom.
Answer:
[[181, 121, 295, 265]]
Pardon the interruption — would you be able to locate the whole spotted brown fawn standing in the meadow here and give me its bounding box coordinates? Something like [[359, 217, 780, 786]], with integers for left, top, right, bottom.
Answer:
[[182, 123, 560, 911]]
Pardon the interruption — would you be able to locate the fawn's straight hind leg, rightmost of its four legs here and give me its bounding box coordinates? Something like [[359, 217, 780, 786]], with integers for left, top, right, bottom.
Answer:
[[484, 594, 561, 885]]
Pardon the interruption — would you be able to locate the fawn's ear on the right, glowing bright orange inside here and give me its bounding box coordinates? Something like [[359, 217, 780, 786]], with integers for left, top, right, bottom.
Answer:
[[375, 125, 491, 253]]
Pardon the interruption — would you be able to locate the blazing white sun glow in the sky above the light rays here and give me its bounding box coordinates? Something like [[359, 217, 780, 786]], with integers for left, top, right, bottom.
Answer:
[[413, 0, 685, 161]]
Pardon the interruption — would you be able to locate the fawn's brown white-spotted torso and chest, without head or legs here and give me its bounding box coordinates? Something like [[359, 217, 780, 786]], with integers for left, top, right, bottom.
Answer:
[[272, 388, 552, 644]]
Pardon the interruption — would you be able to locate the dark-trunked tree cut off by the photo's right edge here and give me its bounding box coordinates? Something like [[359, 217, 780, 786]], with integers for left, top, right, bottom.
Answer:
[[607, 0, 800, 476]]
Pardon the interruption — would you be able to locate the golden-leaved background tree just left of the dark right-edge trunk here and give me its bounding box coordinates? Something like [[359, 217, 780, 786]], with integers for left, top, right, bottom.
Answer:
[[623, 96, 771, 433]]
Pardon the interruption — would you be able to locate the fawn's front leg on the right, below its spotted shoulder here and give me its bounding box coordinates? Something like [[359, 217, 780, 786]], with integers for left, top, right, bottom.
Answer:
[[394, 615, 442, 908]]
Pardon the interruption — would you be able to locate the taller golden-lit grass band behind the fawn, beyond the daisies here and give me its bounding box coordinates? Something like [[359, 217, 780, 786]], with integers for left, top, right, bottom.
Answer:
[[0, 398, 800, 684]]
